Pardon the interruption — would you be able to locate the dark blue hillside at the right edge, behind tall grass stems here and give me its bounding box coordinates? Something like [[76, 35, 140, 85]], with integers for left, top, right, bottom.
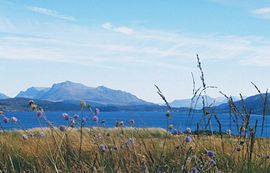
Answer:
[[214, 94, 270, 114]]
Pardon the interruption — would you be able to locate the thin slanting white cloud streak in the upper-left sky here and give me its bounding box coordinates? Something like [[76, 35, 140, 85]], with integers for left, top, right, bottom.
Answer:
[[26, 6, 76, 22]]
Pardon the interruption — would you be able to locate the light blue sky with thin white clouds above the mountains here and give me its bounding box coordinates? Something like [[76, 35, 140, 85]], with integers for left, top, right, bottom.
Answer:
[[0, 0, 270, 103]]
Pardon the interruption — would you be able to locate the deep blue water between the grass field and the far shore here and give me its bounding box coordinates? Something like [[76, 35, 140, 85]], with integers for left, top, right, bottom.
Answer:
[[0, 112, 270, 137]]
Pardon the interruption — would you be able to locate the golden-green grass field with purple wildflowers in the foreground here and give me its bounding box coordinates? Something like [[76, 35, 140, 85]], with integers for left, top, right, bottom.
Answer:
[[0, 127, 270, 173]]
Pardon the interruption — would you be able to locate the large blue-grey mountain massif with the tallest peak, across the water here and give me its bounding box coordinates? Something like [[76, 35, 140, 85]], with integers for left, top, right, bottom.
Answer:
[[16, 81, 152, 106]]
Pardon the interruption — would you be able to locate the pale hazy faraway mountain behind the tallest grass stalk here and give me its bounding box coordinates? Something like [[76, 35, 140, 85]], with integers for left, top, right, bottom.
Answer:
[[170, 96, 230, 109]]
